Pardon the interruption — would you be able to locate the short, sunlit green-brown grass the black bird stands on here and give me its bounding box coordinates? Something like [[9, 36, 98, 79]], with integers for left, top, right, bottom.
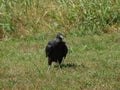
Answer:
[[0, 33, 120, 90]]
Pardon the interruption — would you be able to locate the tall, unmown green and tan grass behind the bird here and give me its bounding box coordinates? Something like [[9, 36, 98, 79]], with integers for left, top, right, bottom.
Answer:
[[0, 0, 120, 36]]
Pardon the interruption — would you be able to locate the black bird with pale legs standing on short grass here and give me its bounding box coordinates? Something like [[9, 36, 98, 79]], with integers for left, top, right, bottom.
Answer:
[[45, 33, 68, 69]]
